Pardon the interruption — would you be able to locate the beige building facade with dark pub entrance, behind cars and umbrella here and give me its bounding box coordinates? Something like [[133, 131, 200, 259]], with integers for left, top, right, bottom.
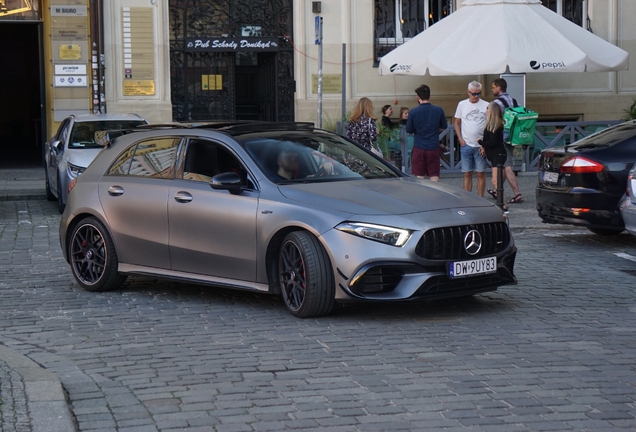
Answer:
[[0, 0, 636, 167]]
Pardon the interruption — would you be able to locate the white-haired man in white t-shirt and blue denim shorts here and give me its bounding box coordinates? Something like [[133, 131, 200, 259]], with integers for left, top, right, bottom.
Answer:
[[454, 81, 488, 197]]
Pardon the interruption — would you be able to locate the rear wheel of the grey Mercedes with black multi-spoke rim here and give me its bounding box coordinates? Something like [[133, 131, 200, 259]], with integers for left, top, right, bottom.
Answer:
[[68, 217, 127, 292]]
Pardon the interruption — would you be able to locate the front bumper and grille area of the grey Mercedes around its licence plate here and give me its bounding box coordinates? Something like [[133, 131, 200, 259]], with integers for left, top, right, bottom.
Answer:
[[324, 219, 517, 302]]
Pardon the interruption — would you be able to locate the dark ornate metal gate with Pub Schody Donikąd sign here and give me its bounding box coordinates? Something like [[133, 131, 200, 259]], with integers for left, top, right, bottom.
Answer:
[[170, 0, 294, 121]]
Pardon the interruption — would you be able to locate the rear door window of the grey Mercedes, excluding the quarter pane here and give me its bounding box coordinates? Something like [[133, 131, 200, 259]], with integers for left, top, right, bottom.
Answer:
[[128, 138, 180, 178]]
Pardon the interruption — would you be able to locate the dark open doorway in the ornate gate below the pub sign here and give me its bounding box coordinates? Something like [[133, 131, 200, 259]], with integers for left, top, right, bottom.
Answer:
[[235, 52, 276, 121]]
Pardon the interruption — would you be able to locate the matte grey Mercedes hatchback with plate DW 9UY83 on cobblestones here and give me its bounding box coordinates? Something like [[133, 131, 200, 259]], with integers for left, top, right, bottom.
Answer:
[[60, 122, 517, 317]]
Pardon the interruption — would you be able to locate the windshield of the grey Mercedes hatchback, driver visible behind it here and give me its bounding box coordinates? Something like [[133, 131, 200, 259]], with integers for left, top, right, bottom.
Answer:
[[239, 131, 400, 184]]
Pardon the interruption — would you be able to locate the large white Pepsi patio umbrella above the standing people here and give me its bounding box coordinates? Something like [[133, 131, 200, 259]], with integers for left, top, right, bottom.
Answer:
[[379, 0, 628, 76]]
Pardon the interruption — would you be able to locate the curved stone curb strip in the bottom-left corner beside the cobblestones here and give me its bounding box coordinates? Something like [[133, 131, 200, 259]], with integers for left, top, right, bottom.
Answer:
[[0, 345, 77, 432]]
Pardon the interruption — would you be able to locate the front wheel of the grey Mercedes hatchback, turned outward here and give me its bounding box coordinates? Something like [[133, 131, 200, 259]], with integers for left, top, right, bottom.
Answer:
[[278, 231, 336, 318]]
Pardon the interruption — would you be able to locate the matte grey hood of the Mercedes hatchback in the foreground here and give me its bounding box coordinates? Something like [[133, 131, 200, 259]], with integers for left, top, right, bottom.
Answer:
[[279, 177, 492, 215]]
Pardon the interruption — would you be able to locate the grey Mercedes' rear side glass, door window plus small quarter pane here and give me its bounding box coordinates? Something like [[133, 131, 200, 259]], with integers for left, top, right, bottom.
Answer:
[[108, 138, 180, 178]]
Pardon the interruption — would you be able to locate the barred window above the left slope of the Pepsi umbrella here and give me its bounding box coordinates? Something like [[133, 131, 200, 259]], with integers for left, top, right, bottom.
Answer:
[[374, 0, 455, 67]]
